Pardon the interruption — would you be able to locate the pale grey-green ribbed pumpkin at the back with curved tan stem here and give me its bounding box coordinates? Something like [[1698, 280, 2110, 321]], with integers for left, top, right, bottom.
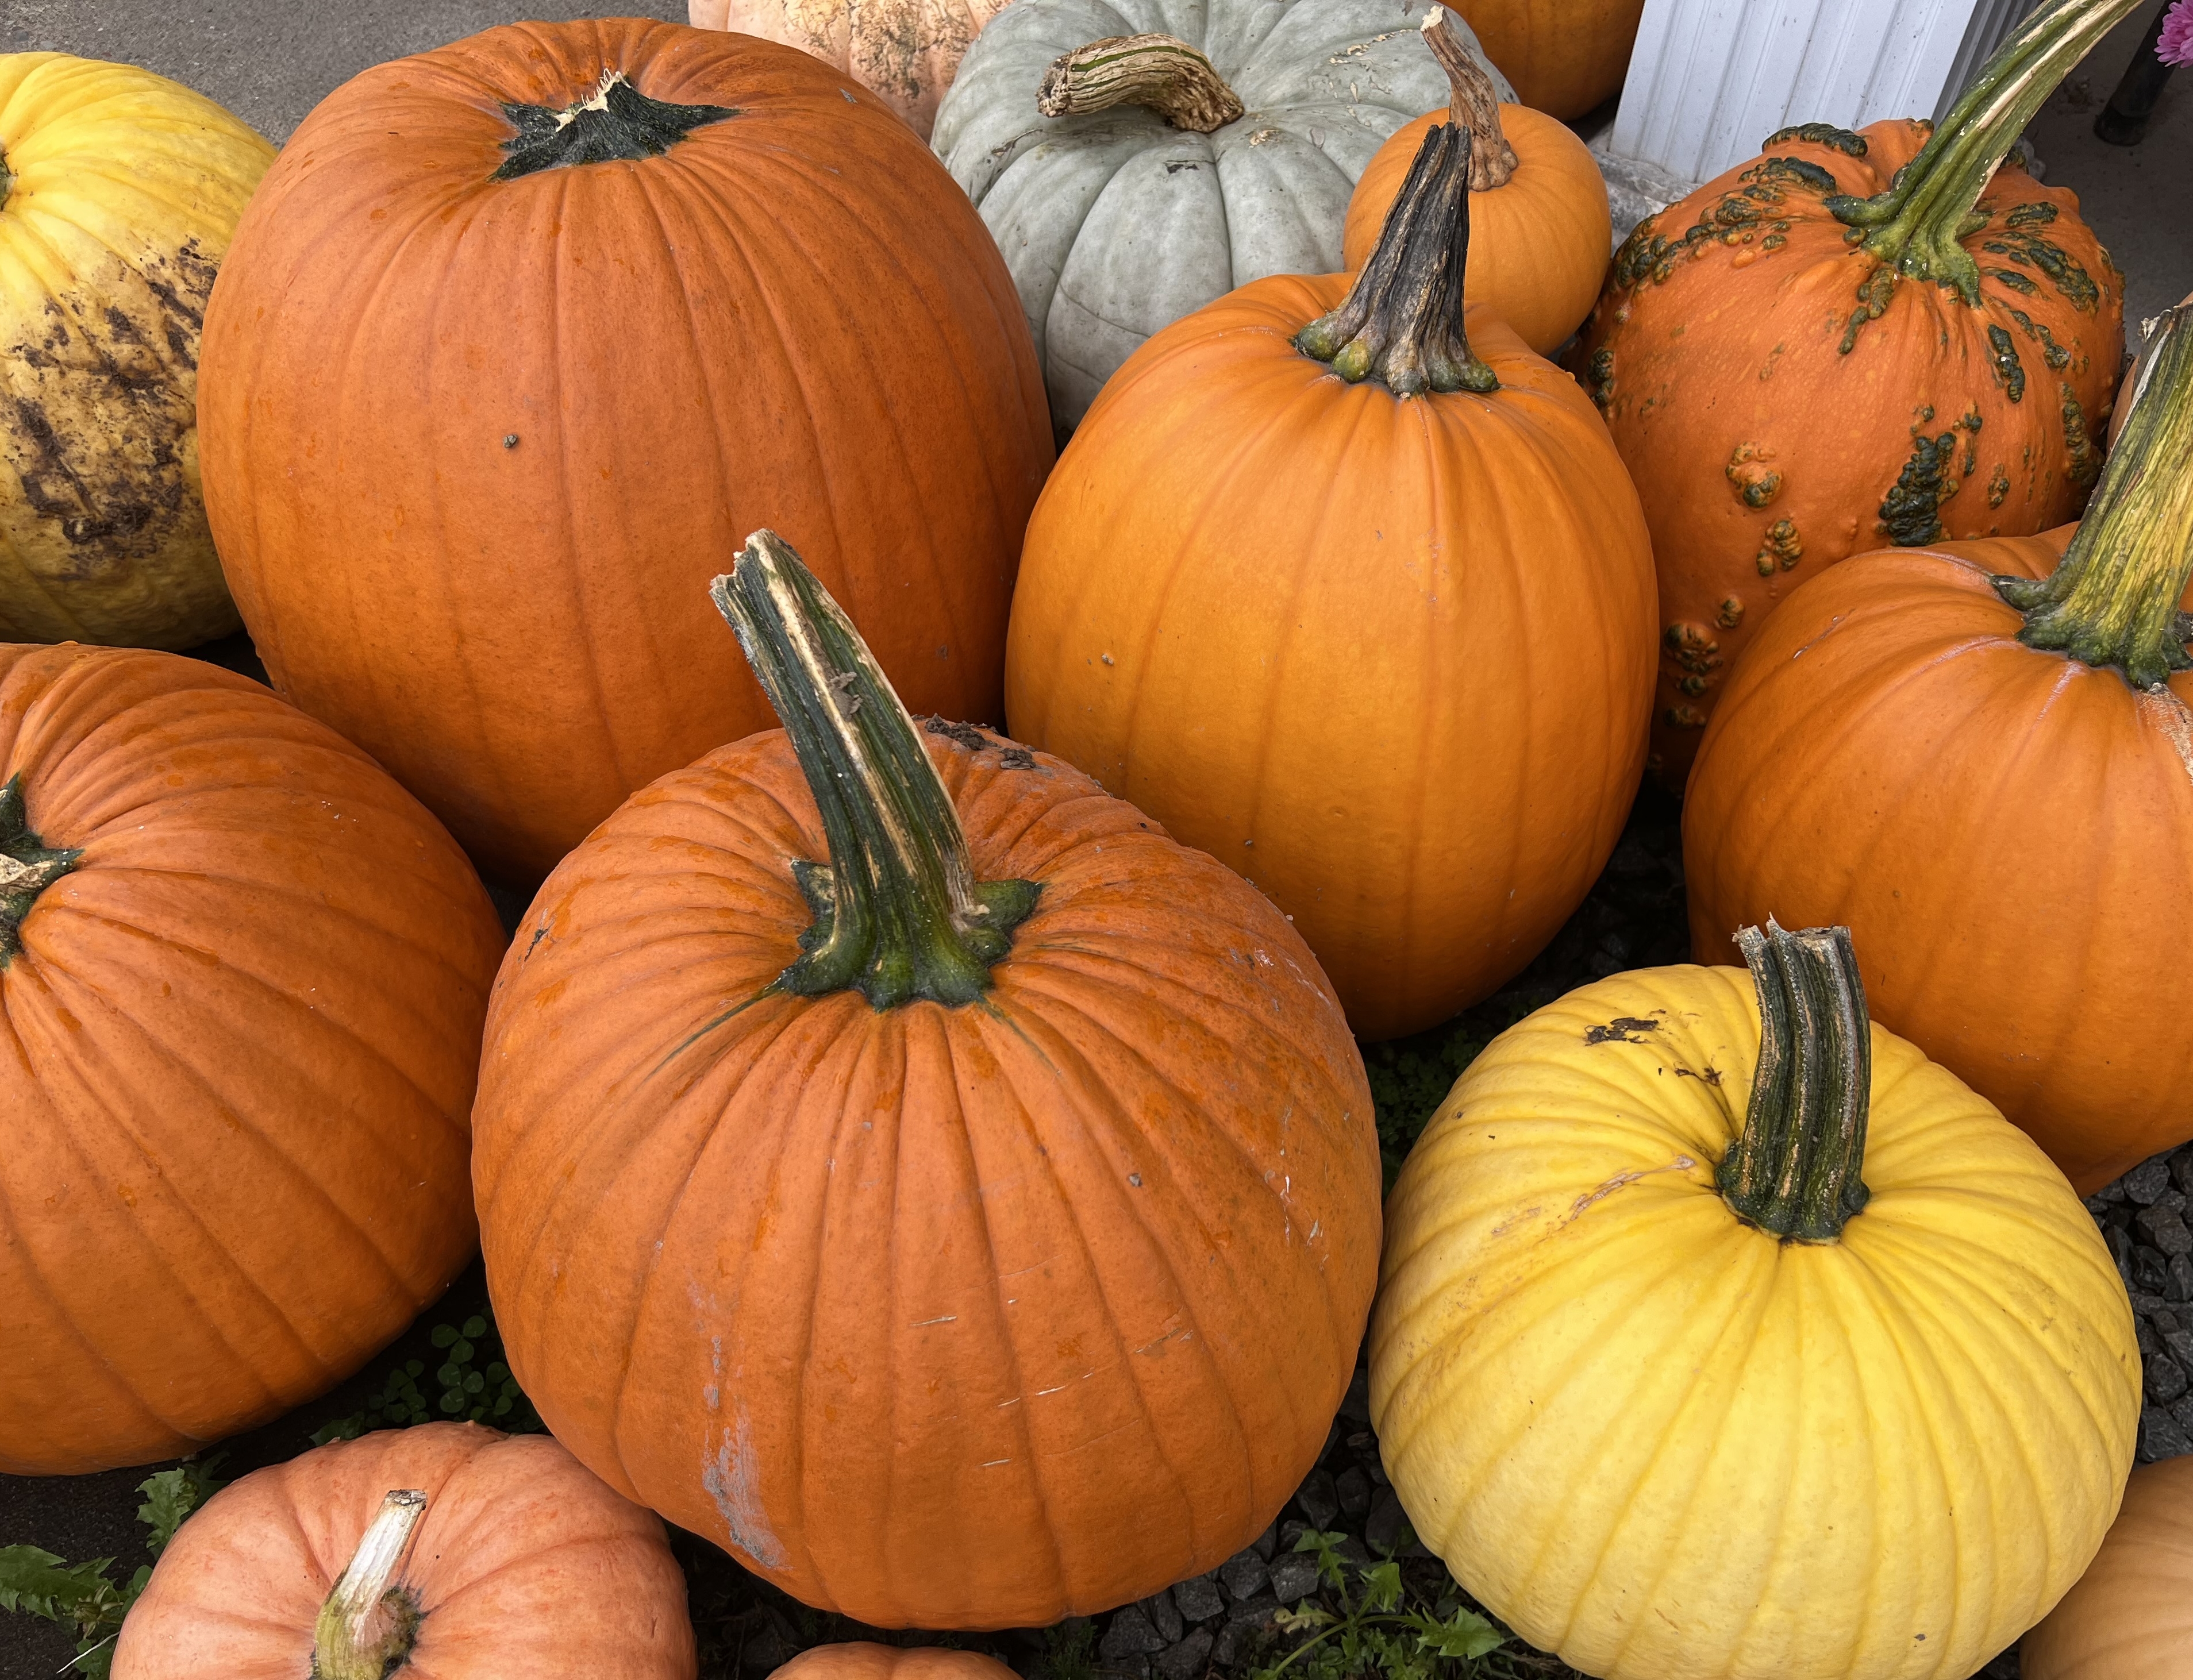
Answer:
[[932, 0, 1515, 432]]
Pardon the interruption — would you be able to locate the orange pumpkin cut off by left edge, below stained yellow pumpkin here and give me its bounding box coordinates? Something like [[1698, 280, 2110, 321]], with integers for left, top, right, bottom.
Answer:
[[0, 642, 505, 1476]]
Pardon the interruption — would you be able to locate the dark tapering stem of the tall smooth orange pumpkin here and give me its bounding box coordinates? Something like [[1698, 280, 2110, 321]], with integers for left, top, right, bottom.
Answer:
[[1294, 123, 1500, 397]]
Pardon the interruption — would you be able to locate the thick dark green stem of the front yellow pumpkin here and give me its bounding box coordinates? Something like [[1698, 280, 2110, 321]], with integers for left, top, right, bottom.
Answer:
[[1717, 917, 1873, 1243]]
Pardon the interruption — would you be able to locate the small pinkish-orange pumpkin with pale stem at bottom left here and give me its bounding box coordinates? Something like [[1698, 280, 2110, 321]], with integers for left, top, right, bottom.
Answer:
[[114, 1423, 695, 1680]]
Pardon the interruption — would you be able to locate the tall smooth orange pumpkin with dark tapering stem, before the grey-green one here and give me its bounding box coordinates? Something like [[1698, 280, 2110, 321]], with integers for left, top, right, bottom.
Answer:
[[1007, 123, 1651, 1038]]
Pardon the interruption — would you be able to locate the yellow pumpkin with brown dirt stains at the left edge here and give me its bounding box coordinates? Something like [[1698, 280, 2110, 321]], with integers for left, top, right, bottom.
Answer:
[[0, 53, 274, 649]]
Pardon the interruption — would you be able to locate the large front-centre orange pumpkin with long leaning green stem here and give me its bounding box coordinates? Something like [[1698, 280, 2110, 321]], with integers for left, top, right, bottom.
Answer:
[[474, 533, 1379, 1627]]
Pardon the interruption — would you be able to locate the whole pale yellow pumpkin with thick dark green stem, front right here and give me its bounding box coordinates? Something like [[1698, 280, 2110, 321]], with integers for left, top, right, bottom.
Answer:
[[1371, 923, 2140, 1680]]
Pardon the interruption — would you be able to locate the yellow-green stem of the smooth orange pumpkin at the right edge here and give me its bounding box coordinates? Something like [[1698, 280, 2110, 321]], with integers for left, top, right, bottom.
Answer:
[[1996, 303, 2193, 689]]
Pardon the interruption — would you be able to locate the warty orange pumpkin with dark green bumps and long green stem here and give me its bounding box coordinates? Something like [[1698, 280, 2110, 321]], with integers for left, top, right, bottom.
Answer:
[[1572, 0, 2134, 789]]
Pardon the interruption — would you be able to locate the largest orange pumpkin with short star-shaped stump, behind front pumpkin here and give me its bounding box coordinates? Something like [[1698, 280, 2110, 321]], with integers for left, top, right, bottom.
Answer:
[[199, 20, 1051, 880]]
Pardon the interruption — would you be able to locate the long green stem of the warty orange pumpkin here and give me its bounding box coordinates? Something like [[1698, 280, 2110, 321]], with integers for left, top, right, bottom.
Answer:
[[1827, 0, 2145, 309]]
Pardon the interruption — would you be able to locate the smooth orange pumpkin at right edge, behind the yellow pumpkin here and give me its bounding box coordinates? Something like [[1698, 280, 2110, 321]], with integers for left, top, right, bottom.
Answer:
[[1682, 305, 2193, 1191]]
